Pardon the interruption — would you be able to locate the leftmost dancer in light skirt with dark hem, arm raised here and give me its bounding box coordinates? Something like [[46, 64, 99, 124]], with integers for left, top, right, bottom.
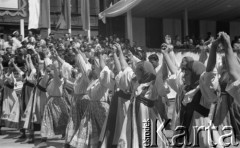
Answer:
[[1, 59, 22, 128]]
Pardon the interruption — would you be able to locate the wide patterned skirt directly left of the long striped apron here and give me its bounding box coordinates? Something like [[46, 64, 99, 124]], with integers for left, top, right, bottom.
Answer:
[[70, 98, 109, 148]]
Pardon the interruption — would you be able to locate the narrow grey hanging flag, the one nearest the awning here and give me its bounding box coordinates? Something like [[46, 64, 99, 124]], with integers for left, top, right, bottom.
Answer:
[[81, 0, 90, 31]]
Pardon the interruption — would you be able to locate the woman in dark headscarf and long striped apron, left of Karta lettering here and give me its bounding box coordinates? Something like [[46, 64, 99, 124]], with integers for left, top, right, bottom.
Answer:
[[118, 61, 168, 148]]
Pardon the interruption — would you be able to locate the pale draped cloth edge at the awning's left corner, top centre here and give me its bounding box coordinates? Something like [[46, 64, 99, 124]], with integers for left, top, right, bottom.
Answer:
[[98, 0, 142, 23]]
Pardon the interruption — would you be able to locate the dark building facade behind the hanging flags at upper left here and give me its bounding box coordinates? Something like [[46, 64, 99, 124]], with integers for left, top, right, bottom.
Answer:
[[0, 0, 100, 37]]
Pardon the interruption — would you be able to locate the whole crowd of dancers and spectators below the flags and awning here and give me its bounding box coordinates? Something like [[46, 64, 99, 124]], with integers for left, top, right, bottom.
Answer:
[[0, 31, 240, 148]]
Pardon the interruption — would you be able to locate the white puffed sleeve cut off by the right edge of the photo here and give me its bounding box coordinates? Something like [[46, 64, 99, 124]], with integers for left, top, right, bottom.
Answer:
[[226, 80, 240, 105]]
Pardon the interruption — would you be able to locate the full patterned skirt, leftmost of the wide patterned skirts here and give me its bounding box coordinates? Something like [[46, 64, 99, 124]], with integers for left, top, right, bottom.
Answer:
[[41, 96, 69, 138]]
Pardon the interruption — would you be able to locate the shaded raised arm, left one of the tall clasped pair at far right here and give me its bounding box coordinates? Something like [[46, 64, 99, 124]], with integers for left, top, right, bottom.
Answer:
[[206, 38, 220, 72]]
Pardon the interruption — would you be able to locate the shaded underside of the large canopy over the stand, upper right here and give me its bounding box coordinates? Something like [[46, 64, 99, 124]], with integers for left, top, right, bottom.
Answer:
[[132, 0, 240, 20]]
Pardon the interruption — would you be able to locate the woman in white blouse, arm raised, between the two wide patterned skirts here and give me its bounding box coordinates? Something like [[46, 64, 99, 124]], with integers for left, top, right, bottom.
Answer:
[[65, 49, 91, 148]]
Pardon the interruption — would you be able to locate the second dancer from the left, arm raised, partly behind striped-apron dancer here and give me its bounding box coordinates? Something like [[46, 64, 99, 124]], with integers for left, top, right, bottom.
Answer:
[[18, 54, 37, 143]]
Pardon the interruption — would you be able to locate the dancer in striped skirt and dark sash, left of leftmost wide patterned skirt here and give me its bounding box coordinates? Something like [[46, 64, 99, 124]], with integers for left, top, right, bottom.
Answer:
[[20, 50, 50, 143]]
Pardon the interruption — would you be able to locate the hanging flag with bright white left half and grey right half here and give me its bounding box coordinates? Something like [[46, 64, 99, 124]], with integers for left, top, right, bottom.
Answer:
[[28, 0, 50, 29]]
